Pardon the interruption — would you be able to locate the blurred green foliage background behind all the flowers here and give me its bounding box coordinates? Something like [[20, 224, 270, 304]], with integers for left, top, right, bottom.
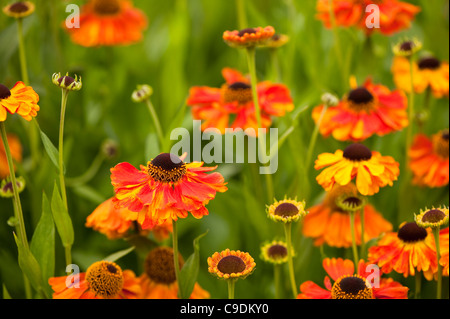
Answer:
[[0, 0, 449, 298]]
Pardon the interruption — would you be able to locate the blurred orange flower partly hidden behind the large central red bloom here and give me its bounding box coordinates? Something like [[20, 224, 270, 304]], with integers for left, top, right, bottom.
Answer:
[[86, 197, 172, 241]]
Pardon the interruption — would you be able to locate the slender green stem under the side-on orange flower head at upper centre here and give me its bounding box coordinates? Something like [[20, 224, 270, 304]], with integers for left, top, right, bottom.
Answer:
[[246, 47, 274, 202]]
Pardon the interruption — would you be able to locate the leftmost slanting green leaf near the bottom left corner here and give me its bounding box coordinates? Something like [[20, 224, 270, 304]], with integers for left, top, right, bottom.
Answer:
[[14, 233, 45, 295]]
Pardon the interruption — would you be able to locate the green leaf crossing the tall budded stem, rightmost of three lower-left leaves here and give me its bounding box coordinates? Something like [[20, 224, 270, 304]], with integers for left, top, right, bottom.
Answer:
[[51, 181, 75, 247]]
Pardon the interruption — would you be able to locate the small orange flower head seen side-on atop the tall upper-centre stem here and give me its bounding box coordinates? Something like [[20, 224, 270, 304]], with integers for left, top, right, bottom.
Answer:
[[223, 26, 275, 48]]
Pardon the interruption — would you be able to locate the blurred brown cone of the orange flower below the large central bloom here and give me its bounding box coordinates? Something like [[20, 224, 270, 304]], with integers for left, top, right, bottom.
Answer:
[[144, 247, 183, 285]]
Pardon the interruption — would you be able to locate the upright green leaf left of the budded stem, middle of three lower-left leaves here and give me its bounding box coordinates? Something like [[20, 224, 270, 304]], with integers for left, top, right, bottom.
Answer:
[[30, 193, 55, 293]]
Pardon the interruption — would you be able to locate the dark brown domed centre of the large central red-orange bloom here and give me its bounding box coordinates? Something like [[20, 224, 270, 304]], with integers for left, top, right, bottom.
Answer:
[[147, 153, 186, 183]]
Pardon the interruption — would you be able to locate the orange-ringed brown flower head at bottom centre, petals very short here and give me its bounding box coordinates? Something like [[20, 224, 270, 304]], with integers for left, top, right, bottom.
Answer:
[[208, 249, 256, 279]]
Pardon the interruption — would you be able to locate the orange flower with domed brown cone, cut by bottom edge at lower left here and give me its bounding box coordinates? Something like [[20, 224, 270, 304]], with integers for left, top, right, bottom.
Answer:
[[48, 261, 141, 299]]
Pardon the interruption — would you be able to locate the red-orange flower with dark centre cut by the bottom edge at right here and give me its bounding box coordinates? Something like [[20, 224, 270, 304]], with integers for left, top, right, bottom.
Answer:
[[297, 258, 408, 299]]
